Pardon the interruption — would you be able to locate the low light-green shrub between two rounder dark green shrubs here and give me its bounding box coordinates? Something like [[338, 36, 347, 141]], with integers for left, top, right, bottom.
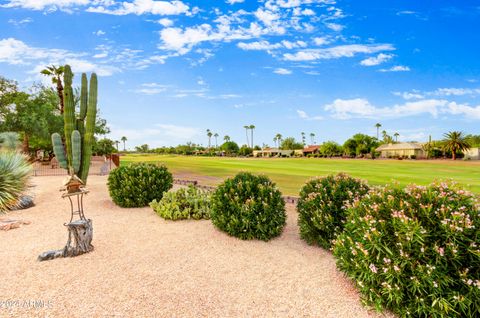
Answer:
[[150, 186, 211, 221]]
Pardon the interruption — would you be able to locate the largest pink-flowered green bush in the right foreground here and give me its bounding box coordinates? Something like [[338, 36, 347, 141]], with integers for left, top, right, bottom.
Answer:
[[333, 183, 480, 317]]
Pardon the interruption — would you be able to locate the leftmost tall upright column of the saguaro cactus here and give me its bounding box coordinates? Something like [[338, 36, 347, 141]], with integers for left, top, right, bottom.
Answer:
[[63, 65, 76, 167]]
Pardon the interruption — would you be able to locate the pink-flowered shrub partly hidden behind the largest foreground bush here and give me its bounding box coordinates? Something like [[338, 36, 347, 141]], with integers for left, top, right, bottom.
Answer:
[[297, 173, 369, 249]]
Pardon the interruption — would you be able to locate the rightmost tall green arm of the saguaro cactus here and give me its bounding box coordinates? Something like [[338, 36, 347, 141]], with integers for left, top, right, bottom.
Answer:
[[79, 73, 98, 184]]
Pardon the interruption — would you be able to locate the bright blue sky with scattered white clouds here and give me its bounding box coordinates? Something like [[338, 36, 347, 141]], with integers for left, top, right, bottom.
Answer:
[[0, 0, 480, 147]]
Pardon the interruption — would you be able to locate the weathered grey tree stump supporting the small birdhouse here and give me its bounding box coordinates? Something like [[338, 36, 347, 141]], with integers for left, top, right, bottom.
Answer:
[[38, 219, 93, 261]]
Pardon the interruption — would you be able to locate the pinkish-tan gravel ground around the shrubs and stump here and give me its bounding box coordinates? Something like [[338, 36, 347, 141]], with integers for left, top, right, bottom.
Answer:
[[0, 176, 392, 318]]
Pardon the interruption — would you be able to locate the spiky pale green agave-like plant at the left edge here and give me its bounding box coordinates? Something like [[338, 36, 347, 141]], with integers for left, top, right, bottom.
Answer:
[[0, 151, 32, 213]]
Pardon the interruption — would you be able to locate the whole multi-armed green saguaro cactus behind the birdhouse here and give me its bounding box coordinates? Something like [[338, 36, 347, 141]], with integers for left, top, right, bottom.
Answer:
[[52, 65, 98, 184]]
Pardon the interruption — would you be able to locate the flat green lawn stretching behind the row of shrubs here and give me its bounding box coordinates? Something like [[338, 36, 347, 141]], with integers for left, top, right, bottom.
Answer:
[[121, 154, 480, 195]]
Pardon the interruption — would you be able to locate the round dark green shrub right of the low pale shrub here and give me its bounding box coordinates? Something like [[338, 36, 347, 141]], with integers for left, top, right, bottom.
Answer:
[[211, 172, 286, 241]]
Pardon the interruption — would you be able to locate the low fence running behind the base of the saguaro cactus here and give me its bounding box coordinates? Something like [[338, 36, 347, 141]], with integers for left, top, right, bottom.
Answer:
[[32, 156, 117, 177]]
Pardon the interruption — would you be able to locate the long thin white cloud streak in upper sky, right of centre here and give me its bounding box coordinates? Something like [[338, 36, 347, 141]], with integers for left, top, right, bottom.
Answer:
[[283, 44, 395, 61]]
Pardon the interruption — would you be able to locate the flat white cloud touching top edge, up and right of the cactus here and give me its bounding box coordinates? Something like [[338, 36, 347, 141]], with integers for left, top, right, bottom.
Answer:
[[87, 0, 189, 15]]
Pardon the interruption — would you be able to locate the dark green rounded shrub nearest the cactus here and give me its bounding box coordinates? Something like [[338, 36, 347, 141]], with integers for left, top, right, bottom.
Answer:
[[108, 163, 173, 208]]
